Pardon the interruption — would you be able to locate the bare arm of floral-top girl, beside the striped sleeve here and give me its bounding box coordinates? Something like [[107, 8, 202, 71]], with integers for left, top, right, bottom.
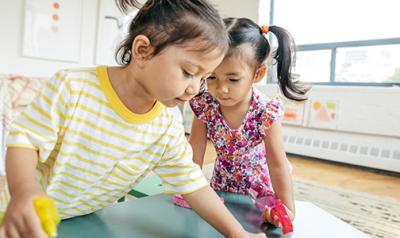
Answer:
[[189, 117, 207, 168]]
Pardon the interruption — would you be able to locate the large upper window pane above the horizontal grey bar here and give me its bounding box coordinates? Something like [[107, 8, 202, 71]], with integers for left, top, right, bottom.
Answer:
[[274, 0, 400, 44]]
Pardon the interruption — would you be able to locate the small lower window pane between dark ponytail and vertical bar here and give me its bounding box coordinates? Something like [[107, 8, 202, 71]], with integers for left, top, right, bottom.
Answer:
[[294, 50, 331, 83]]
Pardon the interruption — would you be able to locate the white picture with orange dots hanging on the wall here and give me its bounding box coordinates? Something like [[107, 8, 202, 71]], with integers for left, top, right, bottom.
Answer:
[[22, 0, 82, 62]]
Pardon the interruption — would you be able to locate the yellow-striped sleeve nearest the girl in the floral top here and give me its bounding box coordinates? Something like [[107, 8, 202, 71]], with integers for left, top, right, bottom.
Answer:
[[154, 120, 208, 194]]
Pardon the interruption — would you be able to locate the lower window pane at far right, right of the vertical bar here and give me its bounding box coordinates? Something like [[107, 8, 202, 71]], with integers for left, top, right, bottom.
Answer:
[[336, 45, 400, 83]]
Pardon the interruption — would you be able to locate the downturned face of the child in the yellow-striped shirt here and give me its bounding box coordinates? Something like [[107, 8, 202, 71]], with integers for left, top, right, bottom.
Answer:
[[142, 40, 223, 107]]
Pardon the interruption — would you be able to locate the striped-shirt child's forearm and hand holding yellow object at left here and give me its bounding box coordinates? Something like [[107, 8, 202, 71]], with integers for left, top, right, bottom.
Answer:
[[1, 147, 47, 238]]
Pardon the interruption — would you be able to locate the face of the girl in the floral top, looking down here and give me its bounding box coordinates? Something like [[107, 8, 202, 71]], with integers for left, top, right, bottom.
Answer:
[[207, 53, 265, 107]]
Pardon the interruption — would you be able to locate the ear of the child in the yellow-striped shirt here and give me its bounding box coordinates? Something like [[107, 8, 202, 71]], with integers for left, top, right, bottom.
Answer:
[[131, 35, 154, 64]]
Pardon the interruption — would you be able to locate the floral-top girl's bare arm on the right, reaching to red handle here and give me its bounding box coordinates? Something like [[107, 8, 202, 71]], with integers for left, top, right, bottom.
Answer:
[[264, 121, 295, 221]]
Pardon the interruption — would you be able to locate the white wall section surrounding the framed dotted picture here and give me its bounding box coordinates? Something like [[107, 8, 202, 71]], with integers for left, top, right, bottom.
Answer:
[[0, 0, 98, 77]]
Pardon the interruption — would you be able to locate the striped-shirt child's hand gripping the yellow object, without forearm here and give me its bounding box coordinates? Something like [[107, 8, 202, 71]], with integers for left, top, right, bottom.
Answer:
[[0, 188, 48, 238]]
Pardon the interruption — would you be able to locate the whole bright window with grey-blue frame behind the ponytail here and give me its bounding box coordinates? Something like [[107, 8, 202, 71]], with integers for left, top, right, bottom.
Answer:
[[260, 0, 400, 86]]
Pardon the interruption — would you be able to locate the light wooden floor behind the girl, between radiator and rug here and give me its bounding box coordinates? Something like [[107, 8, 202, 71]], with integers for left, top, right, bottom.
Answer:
[[204, 142, 400, 200]]
